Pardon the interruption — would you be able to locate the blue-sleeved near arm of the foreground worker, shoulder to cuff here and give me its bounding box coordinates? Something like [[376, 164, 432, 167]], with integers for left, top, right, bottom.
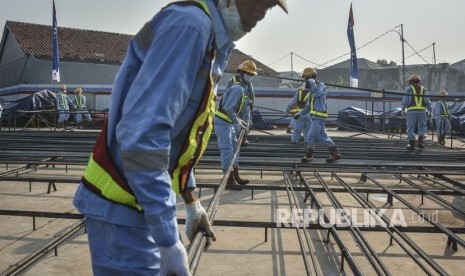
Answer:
[[116, 8, 213, 247]]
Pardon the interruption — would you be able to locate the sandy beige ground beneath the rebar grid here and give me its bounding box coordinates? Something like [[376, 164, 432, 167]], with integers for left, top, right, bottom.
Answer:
[[0, 129, 465, 276]]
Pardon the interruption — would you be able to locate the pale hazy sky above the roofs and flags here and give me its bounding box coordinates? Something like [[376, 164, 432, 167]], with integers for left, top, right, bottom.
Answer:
[[0, 0, 465, 71]]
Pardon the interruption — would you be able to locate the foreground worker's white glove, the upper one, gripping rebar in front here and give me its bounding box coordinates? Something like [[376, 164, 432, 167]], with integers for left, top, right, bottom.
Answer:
[[184, 200, 216, 250]]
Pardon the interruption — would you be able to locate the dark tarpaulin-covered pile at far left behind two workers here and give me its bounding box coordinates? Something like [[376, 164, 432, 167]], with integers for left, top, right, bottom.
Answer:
[[2, 90, 56, 120]]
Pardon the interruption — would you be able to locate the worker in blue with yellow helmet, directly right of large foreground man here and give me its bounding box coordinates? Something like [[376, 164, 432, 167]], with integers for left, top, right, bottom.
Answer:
[[213, 60, 257, 190]]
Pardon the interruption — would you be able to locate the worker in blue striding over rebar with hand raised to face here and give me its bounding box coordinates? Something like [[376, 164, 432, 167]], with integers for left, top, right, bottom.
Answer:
[[294, 67, 342, 163]]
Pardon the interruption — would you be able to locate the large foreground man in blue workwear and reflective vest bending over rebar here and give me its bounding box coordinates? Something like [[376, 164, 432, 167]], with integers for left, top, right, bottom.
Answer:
[[74, 0, 286, 275]]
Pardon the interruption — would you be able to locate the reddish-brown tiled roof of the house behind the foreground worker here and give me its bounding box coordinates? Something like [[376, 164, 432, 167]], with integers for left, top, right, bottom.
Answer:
[[6, 21, 278, 76]]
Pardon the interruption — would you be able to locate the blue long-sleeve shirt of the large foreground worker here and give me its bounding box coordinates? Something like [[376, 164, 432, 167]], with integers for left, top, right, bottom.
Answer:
[[75, 0, 234, 246]]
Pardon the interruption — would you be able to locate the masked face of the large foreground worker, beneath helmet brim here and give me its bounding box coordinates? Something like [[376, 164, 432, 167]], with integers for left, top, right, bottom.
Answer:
[[218, 0, 277, 41]]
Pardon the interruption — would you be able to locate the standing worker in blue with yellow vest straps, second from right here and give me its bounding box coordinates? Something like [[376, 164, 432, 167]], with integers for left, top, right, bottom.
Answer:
[[402, 74, 431, 150]]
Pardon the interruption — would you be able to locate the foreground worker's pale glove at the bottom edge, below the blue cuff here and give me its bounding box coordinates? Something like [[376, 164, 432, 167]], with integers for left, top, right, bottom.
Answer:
[[160, 240, 191, 276]]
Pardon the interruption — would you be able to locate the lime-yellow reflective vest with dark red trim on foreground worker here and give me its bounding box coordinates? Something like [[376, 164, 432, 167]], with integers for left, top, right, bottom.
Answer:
[[82, 0, 216, 211]]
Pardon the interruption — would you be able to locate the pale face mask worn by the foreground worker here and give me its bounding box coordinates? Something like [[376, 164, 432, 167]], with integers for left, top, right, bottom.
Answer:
[[218, 0, 246, 41]]
